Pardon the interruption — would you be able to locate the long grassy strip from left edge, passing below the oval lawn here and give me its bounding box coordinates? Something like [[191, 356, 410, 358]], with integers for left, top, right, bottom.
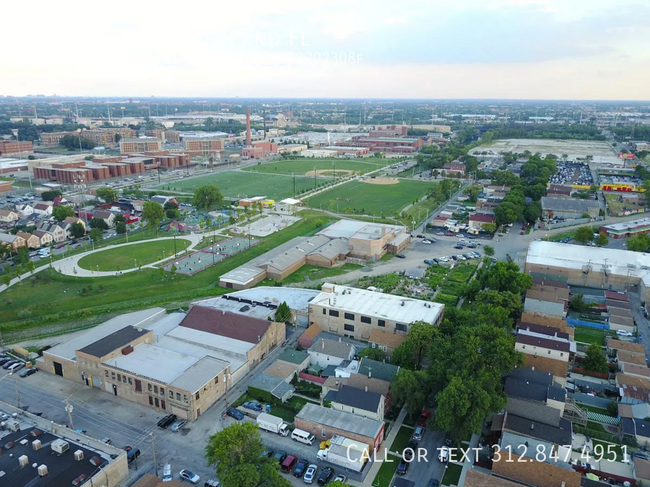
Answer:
[[0, 211, 331, 341]]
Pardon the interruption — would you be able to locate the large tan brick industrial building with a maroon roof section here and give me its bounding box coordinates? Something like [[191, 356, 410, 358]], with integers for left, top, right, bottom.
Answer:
[[36, 305, 285, 420]]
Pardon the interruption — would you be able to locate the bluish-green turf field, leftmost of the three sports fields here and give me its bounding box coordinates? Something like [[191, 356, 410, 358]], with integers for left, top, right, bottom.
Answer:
[[155, 171, 314, 200]]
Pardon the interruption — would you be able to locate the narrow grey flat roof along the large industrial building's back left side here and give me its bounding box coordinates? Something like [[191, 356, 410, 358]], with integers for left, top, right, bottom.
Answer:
[[45, 308, 166, 360]]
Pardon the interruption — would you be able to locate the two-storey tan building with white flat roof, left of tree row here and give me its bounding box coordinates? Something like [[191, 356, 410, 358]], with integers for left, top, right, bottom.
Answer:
[[309, 284, 445, 341]]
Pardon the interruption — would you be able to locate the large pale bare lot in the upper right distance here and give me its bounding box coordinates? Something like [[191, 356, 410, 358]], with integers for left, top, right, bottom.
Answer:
[[470, 139, 618, 163]]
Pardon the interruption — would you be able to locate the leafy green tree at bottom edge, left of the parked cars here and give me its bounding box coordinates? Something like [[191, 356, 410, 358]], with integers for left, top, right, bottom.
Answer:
[[205, 422, 291, 487]]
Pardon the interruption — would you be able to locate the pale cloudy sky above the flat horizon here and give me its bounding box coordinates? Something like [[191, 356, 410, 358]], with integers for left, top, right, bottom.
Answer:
[[0, 0, 650, 100]]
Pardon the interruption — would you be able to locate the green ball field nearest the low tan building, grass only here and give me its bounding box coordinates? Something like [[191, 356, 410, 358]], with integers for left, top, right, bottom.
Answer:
[[307, 179, 435, 217]]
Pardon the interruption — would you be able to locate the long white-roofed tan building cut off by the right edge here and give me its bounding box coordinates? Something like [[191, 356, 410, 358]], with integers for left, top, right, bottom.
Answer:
[[524, 241, 650, 304]]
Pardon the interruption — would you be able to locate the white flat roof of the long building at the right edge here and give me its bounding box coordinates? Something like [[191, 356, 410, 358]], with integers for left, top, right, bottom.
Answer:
[[526, 241, 650, 285]]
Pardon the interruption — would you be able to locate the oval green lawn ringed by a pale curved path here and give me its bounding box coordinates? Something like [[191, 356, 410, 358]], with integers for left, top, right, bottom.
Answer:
[[79, 238, 191, 271]]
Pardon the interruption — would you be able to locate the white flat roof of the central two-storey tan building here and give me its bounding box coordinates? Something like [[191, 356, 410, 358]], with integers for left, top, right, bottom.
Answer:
[[311, 284, 444, 323]]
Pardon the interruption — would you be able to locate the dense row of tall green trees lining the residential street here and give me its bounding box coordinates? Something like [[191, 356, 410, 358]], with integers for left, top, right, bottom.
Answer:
[[391, 262, 532, 441]]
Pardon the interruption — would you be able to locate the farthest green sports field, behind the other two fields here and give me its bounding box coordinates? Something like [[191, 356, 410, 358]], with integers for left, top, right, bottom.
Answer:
[[243, 157, 388, 179]]
